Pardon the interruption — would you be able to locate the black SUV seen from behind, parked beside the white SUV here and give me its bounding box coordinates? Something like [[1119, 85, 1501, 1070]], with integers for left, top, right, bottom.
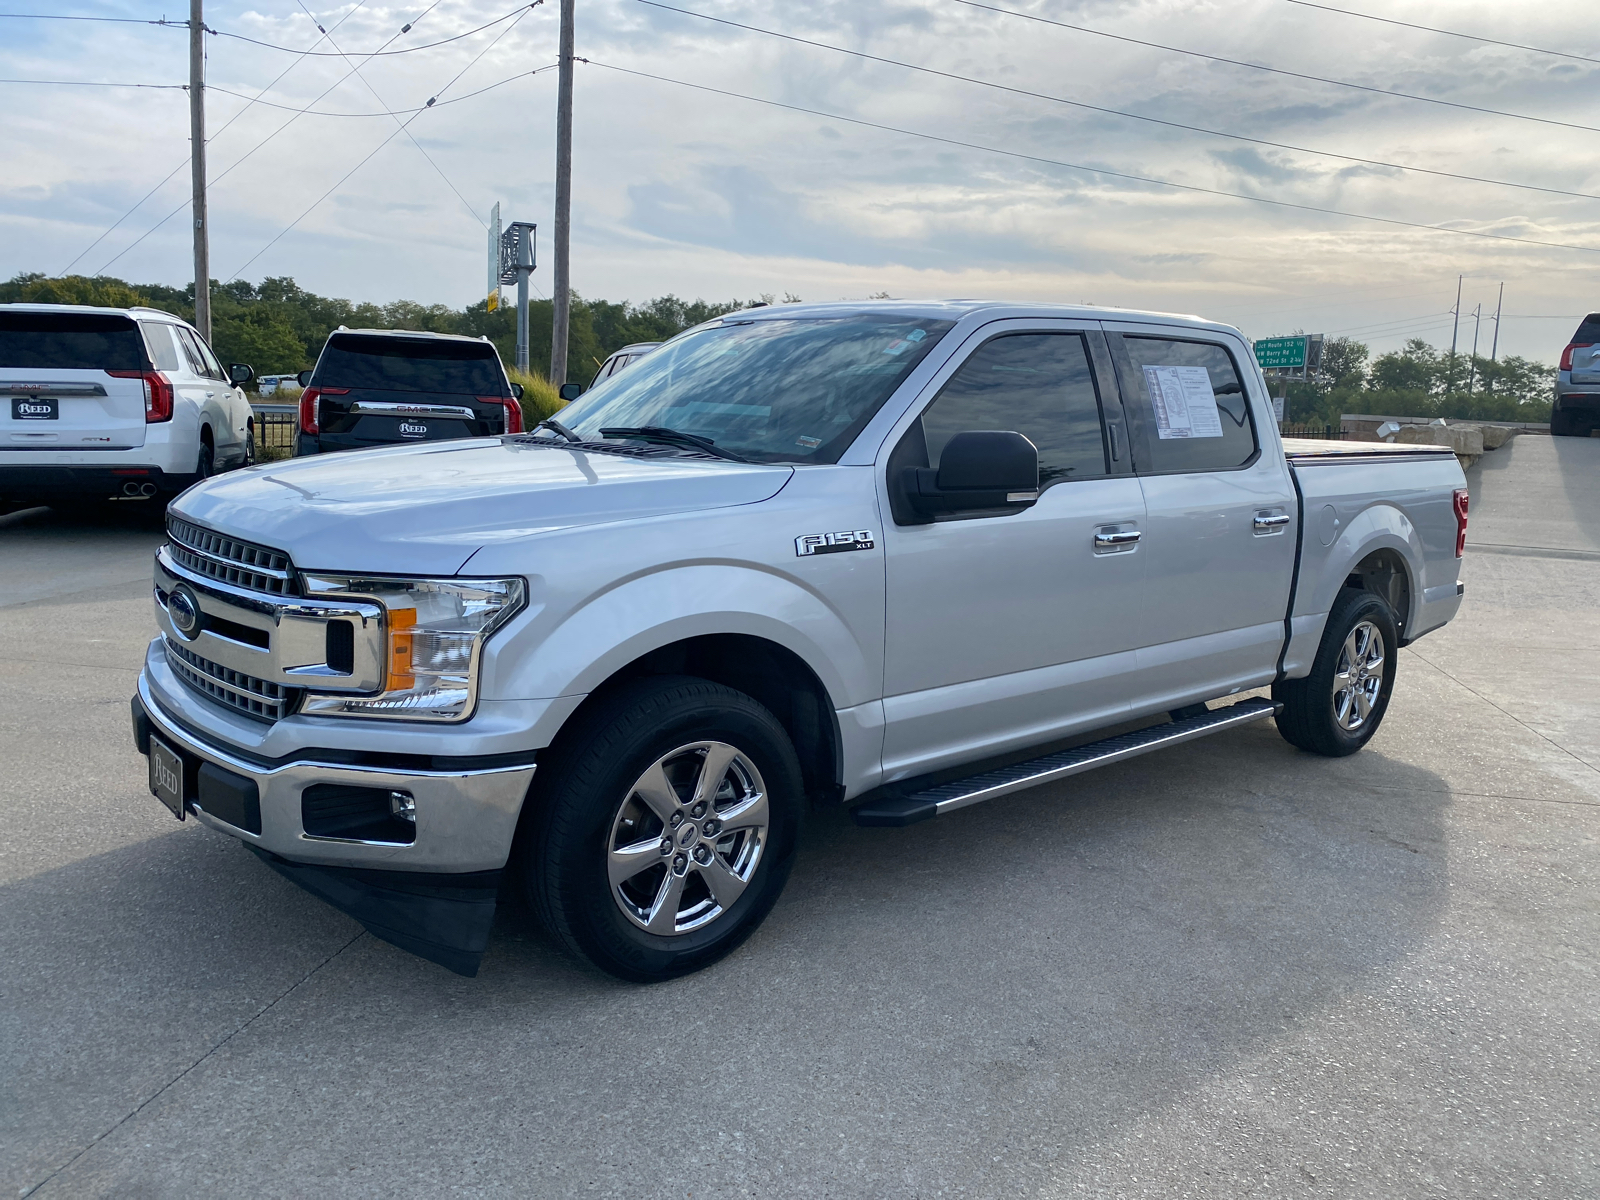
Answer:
[[294, 328, 522, 454]]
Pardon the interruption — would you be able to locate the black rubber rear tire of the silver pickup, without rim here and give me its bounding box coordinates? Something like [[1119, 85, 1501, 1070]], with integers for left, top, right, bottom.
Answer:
[[1272, 587, 1400, 758]]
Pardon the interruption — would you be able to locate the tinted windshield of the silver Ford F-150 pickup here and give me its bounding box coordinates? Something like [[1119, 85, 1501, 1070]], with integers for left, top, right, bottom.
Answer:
[[558, 314, 954, 462]]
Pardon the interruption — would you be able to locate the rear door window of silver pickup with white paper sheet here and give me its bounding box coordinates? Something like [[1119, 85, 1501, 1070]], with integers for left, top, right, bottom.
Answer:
[[1120, 334, 1256, 474]]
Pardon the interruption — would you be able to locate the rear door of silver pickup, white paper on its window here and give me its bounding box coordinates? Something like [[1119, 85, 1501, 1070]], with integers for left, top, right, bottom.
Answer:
[[1107, 325, 1299, 712]]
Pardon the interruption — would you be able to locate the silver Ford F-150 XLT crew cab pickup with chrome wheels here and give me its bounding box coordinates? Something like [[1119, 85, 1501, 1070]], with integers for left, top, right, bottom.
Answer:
[[133, 301, 1467, 981]]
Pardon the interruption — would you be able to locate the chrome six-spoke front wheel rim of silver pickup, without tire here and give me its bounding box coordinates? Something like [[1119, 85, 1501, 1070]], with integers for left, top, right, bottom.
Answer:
[[606, 742, 768, 936]]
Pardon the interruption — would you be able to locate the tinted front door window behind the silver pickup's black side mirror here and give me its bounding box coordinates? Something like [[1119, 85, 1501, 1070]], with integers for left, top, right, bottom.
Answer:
[[922, 333, 1106, 488]]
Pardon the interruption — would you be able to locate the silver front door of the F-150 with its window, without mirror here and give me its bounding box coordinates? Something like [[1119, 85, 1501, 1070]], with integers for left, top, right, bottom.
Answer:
[[883, 322, 1144, 781]]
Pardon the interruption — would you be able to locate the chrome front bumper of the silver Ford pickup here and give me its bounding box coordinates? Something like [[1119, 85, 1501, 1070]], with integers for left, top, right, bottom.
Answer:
[[138, 670, 534, 874]]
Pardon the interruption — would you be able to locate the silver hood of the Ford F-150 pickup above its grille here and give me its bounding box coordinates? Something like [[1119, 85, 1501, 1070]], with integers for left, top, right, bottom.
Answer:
[[171, 438, 794, 574]]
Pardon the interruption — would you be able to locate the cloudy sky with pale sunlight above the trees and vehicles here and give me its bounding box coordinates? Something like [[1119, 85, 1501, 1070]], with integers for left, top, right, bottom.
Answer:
[[0, 0, 1600, 362]]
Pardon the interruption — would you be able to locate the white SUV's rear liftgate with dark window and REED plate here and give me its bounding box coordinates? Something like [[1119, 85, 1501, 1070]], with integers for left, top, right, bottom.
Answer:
[[0, 309, 149, 450]]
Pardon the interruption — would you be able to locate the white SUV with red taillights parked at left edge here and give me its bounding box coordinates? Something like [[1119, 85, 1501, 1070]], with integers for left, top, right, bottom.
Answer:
[[0, 304, 256, 504]]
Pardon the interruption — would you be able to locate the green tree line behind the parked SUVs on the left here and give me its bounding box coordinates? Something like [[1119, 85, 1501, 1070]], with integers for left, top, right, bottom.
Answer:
[[0, 274, 774, 382]]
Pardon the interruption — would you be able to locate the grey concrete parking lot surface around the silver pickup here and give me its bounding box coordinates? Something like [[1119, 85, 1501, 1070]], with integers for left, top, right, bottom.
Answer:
[[0, 437, 1600, 1197]]
